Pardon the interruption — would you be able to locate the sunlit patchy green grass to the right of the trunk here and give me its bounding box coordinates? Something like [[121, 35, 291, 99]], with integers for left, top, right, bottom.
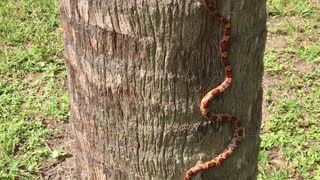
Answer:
[[258, 0, 320, 179]]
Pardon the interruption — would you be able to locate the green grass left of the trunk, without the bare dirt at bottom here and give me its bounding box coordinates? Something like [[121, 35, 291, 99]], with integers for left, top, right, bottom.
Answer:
[[0, 0, 68, 179]]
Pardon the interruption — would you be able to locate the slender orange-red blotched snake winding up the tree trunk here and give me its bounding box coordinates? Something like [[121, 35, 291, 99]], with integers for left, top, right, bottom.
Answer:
[[184, 0, 243, 180]]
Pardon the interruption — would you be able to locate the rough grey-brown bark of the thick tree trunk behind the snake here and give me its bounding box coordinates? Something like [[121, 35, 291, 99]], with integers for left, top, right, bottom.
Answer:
[[61, 0, 266, 179]]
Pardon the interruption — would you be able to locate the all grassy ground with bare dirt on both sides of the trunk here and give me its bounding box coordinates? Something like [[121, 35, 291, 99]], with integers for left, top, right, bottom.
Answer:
[[0, 0, 320, 179]]
